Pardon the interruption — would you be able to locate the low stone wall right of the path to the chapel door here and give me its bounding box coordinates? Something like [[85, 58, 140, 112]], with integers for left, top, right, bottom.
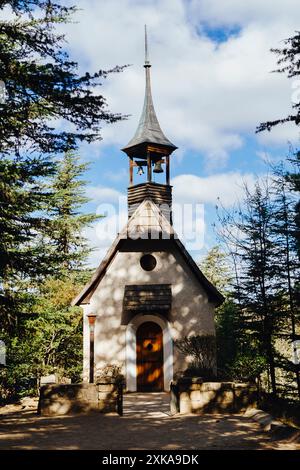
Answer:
[[171, 377, 257, 414]]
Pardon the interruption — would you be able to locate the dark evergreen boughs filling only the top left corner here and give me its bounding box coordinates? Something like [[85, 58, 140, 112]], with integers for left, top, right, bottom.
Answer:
[[0, 0, 122, 157]]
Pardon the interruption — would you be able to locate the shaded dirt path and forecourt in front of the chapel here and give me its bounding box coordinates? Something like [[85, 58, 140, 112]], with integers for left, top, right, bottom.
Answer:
[[0, 394, 299, 450]]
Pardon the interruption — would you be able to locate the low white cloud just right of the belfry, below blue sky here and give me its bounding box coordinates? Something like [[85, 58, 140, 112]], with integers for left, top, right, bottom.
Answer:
[[172, 172, 255, 207]]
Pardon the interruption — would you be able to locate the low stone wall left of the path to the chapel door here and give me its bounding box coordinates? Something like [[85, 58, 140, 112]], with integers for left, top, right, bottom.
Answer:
[[38, 379, 122, 416]]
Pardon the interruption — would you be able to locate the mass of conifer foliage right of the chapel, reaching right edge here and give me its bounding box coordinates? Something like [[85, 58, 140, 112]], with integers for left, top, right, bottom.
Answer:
[[216, 167, 300, 395]]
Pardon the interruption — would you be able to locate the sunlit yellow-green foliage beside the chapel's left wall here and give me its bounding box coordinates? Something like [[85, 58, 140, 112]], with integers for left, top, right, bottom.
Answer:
[[24, 274, 82, 382]]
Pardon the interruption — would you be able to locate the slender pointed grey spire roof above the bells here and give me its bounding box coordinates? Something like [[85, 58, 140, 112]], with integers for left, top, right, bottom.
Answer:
[[122, 25, 177, 152]]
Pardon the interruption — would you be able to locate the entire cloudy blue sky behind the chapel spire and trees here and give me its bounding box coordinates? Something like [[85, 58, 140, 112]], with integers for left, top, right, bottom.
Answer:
[[55, 0, 300, 265]]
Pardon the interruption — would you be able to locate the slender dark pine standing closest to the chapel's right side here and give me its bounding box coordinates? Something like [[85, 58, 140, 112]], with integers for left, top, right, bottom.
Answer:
[[220, 183, 280, 395]]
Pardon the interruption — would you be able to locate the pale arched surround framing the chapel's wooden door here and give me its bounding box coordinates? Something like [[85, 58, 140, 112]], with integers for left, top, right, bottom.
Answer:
[[125, 314, 173, 392]]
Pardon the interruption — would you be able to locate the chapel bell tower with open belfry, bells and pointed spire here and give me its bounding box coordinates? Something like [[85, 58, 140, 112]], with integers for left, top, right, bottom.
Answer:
[[122, 26, 177, 223]]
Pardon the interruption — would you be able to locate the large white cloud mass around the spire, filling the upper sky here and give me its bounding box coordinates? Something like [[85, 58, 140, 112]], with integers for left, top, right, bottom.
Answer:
[[59, 0, 299, 167]]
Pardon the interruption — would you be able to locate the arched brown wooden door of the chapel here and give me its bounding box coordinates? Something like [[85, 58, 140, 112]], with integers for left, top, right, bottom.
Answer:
[[136, 322, 164, 392]]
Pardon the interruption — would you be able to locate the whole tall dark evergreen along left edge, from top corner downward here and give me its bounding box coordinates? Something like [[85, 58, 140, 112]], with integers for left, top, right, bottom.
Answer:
[[0, 0, 122, 328]]
